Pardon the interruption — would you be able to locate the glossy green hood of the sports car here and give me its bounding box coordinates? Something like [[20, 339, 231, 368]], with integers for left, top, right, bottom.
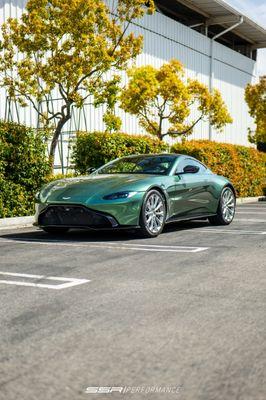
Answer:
[[40, 174, 158, 203]]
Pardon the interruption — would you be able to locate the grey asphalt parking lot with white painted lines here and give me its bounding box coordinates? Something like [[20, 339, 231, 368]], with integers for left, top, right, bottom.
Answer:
[[0, 202, 266, 400]]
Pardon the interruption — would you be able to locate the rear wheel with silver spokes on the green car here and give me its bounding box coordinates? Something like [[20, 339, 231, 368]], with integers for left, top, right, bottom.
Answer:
[[209, 186, 236, 225]]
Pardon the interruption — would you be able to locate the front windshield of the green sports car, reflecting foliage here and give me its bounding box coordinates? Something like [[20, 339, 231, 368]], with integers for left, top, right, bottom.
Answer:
[[96, 155, 176, 175]]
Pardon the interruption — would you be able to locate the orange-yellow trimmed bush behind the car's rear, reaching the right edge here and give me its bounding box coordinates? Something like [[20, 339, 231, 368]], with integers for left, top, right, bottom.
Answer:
[[171, 140, 266, 197]]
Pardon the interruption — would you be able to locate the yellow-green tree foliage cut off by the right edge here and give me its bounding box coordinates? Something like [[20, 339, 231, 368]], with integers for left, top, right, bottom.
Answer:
[[245, 76, 266, 143]]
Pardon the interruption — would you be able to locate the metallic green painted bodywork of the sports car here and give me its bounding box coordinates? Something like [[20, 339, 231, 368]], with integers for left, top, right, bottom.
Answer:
[[36, 156, 233, 226]]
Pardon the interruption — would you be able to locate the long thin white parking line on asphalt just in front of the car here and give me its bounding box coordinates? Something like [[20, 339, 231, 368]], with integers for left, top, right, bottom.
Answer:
[[0, 238, 208, 253]]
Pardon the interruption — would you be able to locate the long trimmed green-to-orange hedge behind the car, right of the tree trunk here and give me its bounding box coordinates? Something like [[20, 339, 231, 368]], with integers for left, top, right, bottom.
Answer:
[[73, 132, 266, 197]]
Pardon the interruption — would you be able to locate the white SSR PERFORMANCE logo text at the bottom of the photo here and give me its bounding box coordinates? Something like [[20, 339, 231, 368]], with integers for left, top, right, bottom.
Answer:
[[85, 386, 182, 394]]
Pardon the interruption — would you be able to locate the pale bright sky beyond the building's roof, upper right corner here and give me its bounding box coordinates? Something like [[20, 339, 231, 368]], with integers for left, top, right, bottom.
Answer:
[[225, 0, 266, 75]]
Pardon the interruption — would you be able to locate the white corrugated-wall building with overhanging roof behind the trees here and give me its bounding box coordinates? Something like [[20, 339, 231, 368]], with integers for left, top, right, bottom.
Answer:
[[0, 0, 266, 172]]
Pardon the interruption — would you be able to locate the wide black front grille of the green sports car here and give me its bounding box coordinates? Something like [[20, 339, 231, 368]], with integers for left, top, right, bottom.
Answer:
[[38, 205, 113, 228]]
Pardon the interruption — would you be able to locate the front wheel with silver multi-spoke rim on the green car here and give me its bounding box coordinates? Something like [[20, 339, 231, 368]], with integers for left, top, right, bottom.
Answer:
[[140, 189, 166, 238]]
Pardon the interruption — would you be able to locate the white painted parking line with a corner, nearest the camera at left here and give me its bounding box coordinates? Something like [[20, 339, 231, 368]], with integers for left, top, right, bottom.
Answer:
[[0, 271, 90, 290]]
